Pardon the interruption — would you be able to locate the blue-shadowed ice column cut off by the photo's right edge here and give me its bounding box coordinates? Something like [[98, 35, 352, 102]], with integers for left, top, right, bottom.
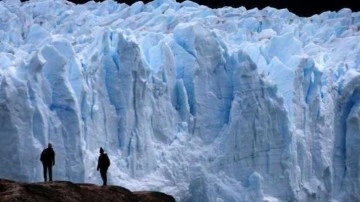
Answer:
[[333, 72, 360, 201]]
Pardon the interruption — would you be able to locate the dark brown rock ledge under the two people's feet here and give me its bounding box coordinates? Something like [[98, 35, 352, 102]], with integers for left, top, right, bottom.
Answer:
[[0, 179, 175, 202]]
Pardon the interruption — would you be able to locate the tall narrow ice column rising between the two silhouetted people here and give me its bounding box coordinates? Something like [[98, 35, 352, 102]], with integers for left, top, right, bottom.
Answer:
[[40, 46, 84, 182]]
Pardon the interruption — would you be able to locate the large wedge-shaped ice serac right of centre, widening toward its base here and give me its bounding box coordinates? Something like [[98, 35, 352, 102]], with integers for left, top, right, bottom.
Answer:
[[221, 51, 294, 199]]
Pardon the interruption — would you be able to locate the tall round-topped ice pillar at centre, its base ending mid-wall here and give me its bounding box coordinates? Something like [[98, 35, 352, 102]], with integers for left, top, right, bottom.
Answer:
[[174, 24, 232, 142]]
